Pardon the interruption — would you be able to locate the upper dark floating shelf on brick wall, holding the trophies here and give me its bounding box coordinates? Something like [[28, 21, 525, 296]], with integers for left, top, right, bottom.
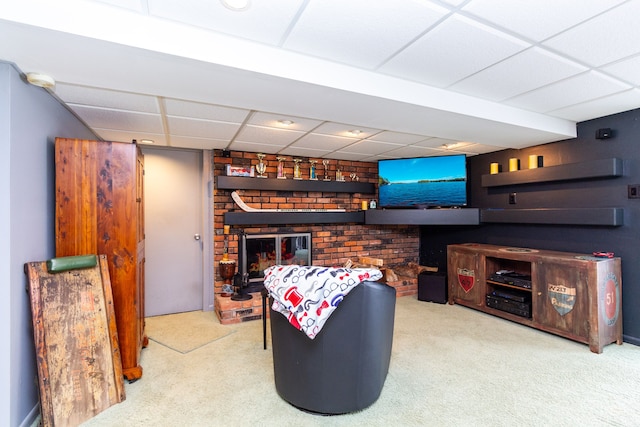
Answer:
[[217, 175, 376, 194]]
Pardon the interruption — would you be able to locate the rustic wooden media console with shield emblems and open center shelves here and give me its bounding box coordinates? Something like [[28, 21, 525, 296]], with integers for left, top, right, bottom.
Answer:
[[447, 243, 622, 353]]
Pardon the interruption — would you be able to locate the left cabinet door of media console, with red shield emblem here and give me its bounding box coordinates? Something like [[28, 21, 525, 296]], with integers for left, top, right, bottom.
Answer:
[[448, 246, 486, 307]]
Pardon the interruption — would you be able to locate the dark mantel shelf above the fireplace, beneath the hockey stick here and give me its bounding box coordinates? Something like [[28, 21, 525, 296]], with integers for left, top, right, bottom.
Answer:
[[224, 211, 364, 225]]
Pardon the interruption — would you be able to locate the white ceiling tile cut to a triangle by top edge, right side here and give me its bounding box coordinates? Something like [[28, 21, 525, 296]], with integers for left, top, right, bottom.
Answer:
[[462, 0, 624, 41]]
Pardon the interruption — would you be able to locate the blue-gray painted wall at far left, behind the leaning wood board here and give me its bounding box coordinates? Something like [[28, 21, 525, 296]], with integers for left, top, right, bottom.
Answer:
[[0, 62, 97, 427]]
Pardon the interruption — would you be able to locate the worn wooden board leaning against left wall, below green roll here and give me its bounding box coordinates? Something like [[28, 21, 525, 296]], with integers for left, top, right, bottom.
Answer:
[[25, 255, 125, 427]]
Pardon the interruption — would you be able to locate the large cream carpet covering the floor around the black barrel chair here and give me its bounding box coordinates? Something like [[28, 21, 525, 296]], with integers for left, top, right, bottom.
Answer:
[[85, 296, 640, 427]]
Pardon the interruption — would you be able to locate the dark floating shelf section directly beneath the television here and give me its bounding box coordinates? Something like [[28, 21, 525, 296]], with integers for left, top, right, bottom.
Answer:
[[365, 208, 480, 225]]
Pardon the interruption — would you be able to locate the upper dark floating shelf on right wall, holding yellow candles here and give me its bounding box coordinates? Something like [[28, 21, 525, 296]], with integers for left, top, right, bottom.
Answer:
[[482, 157, 622, 187]]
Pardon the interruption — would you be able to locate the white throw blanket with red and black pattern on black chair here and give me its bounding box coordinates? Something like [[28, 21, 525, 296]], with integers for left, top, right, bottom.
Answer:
[[264, 265, 382, 339]]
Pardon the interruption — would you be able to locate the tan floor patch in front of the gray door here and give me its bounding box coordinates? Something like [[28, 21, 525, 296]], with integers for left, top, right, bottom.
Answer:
[[145, 311, 234, 354]]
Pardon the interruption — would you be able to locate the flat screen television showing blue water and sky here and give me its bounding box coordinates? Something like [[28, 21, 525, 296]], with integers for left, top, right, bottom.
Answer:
[[378, 154, 467, 209]]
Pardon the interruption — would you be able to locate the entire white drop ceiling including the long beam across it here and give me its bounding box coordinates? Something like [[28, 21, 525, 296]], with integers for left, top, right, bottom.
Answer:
[[0, 0, 640, 161]]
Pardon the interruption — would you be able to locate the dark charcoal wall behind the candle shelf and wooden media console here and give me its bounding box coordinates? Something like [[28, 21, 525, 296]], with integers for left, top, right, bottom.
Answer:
[[420, 109, 640, 345]]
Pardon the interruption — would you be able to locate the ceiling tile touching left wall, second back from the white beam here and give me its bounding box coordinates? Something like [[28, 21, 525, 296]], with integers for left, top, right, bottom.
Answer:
[[70, 105, 163, 133]]
